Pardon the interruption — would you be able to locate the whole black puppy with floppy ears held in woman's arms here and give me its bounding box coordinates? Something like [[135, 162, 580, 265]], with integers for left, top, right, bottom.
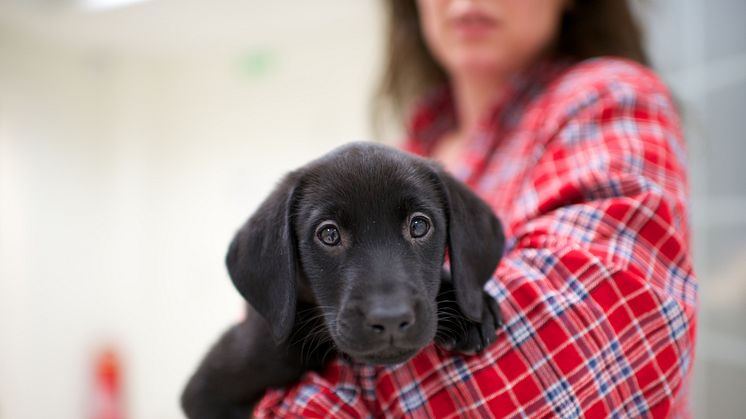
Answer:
[[182, 143, 504, 419]]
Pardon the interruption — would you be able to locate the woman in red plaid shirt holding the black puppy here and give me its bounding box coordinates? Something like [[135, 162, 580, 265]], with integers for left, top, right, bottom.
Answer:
[[256, 0, 696, 417]]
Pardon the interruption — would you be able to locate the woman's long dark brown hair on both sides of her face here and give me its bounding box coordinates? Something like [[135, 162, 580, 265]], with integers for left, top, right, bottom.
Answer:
[[373, 0, 649, 127]]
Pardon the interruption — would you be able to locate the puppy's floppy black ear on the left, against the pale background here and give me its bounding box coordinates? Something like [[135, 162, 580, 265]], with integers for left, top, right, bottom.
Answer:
[[226, 174, 298, 342]]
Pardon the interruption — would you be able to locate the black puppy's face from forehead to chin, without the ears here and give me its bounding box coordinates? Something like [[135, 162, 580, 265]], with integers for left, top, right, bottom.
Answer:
[[292, 151, 447, 364]]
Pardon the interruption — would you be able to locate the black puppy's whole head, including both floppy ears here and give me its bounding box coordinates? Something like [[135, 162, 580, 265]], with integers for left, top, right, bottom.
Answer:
[[227, 144, 503, 364]]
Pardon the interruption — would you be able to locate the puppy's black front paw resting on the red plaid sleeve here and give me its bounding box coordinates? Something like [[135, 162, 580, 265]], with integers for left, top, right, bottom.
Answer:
[[435, 282, 502, 355]]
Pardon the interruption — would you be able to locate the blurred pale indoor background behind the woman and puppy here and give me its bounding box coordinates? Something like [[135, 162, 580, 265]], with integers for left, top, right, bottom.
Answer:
[[0, 0, 746, 419]]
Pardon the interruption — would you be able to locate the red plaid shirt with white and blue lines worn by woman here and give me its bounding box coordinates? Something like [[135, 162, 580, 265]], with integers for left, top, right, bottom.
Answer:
[[255, 58, 697, 418]]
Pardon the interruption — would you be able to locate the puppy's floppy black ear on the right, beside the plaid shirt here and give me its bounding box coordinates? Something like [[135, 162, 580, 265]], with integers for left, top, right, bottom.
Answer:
[[435, 168, 505, 322]]
